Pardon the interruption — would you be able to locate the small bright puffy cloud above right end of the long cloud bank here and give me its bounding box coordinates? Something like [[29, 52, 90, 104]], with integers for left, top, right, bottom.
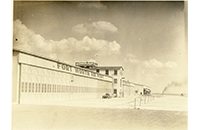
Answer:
[[92, 21, 118, 33]]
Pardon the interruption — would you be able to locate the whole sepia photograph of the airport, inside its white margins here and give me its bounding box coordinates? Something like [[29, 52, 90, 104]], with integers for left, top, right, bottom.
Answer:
[[11, 0, 188, 130]]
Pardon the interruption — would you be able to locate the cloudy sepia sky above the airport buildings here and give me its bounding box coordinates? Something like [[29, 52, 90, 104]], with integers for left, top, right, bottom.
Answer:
[[13, 1, 188, 92]]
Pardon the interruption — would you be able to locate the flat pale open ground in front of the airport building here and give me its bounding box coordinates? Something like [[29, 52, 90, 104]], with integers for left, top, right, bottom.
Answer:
[[12, 96, 188, 130]]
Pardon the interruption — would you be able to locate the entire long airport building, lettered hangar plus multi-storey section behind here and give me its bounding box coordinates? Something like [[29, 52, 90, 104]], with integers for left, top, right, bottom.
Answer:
[[12, 49, 150, 104]]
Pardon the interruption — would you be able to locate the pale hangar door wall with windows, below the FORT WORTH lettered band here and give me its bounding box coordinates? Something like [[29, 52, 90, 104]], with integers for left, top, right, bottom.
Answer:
[[20, 64, 112, 103]]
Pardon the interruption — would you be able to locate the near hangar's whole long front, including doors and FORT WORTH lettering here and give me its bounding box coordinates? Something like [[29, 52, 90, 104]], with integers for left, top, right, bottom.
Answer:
[[12, 51, 113, 103]]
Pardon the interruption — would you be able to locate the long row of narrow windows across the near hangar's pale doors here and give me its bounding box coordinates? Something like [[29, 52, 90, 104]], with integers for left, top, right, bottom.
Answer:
[[21, 82, 111, 93]]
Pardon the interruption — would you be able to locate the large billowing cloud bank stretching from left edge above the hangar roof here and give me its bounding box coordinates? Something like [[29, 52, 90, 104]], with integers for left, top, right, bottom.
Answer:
[[13, 20, 121, 59]]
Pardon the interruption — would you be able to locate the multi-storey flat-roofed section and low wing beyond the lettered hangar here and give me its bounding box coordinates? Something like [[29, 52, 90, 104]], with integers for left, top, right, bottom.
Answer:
[[75, 62, 151, 97]]
